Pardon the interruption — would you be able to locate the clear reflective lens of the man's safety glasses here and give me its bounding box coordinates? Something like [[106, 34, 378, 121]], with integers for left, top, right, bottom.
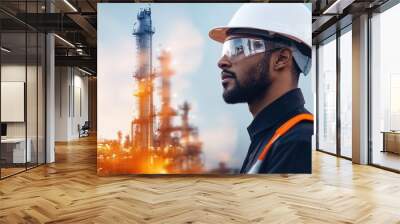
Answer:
[[222, 38, 265, 57]]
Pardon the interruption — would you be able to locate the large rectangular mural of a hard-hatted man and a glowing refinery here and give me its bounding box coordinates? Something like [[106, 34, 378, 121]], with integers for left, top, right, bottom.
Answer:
[[97, 3, 313, 176]]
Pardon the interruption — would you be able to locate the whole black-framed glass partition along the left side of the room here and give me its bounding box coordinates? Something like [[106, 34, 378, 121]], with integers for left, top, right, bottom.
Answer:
[[0, 1, 46, 179]]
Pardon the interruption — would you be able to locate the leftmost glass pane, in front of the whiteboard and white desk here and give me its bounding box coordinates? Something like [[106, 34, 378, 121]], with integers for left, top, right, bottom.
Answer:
[[0, 32, 27, 177]]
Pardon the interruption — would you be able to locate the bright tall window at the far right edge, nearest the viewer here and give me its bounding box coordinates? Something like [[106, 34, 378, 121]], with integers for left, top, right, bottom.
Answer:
[[370, 4, 400, 170]]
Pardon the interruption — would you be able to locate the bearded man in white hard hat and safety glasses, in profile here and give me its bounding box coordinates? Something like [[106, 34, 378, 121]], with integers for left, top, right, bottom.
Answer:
[[209, 3, 313, 173]]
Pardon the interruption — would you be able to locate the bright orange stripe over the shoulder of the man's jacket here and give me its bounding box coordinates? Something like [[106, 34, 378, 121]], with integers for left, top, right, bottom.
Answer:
[[258, 114, 314, 161]]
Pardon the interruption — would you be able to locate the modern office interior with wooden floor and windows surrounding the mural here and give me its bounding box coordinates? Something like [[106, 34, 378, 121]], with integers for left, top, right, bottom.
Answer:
[[0, 0, 400, 223]]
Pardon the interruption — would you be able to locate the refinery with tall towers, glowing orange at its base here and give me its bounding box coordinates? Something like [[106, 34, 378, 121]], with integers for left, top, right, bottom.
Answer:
[[108, 8, 203, 173]]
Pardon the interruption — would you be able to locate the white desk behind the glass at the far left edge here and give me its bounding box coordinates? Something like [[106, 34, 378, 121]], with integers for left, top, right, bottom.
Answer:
[[1, 138, 32, 163]]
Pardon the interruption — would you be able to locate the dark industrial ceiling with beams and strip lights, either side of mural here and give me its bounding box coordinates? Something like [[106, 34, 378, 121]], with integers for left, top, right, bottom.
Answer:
[[0, 0, 394, 73]]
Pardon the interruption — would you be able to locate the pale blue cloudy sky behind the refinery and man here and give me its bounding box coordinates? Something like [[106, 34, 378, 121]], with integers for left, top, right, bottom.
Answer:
[[97, 3, 313, 168]]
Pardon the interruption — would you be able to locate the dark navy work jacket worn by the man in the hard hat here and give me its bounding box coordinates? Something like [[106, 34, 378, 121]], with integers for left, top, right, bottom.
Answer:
[[240, 88, 313, 173]]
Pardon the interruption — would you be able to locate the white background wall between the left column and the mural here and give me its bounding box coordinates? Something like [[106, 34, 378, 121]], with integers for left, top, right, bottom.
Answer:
[[55, 67, 88, 141]]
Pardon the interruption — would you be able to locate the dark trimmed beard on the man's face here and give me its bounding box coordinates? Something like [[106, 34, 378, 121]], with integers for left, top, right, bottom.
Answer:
[[222, 57, 271, 104]]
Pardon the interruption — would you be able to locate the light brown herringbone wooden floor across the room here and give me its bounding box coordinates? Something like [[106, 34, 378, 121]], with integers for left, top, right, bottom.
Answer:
[[0, 138, 400, 224]]
